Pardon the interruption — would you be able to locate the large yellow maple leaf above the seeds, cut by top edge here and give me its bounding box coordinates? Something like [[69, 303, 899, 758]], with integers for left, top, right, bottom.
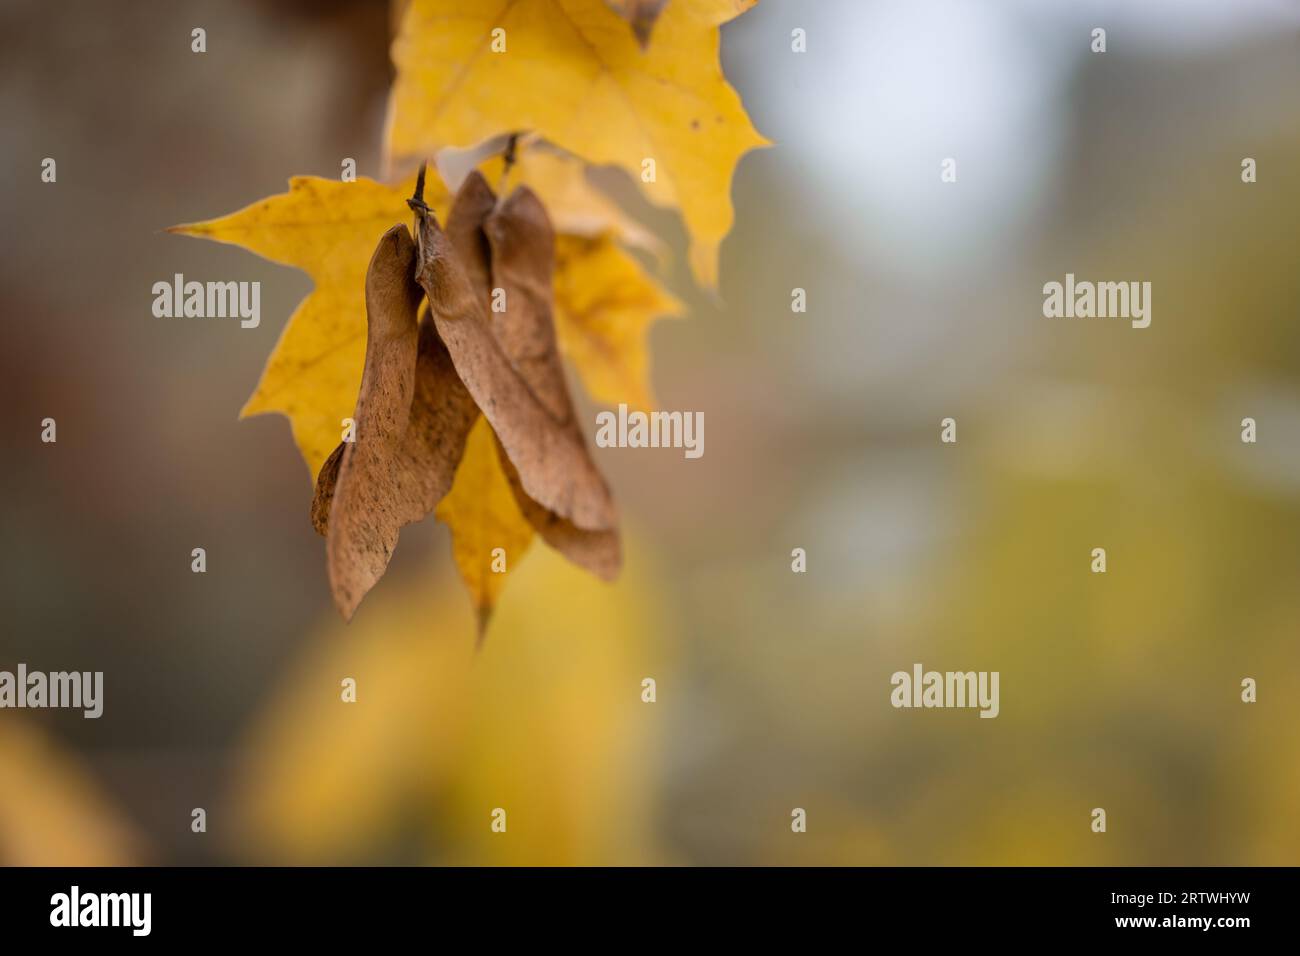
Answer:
[[386, 0, 768, 286]]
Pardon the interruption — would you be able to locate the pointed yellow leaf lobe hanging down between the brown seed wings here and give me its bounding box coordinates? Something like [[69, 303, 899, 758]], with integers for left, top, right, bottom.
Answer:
[[433, 415, 533, 632]]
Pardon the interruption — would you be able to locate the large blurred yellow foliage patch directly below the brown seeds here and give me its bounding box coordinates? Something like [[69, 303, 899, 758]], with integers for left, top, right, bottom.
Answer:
[[237, 530, 672, 865]]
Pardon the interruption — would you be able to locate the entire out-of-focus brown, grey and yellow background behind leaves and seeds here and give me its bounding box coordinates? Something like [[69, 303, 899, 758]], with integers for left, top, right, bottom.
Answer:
[[0, 0, 1300, 865]]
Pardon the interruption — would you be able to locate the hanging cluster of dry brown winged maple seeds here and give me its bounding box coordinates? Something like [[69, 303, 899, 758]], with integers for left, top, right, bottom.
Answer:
[[312, 162, 621, 626]]
